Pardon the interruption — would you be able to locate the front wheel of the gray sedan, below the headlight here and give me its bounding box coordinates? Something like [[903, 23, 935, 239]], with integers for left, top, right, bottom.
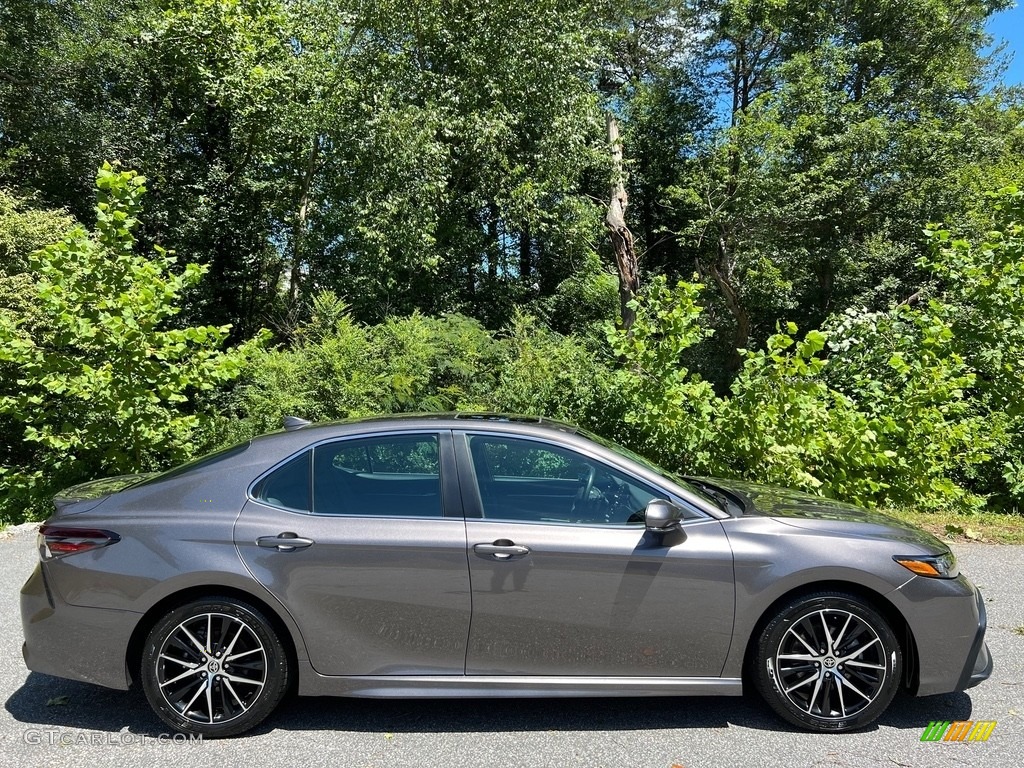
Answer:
[[755, 592, 903, 733]]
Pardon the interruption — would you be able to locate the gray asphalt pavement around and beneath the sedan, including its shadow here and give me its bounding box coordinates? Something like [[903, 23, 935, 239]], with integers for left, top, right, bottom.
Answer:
[[0, 527, 1024, 768]]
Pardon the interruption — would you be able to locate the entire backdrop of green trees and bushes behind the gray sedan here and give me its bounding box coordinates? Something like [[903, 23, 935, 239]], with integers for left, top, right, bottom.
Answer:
[[0, 0, 1024, 519]]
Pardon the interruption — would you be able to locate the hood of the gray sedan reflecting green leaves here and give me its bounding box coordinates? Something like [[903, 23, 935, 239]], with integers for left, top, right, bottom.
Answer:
[[693, 477, 949, 551]]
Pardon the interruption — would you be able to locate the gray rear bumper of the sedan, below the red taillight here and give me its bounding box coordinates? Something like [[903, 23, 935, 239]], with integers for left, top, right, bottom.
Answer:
[[22, 564, 141, 690]]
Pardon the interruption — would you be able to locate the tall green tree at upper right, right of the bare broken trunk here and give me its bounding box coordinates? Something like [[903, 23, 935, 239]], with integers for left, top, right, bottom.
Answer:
[[666, 0, 1017, 380]]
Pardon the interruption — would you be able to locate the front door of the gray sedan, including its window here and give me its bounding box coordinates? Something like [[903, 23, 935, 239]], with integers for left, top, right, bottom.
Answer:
[[456, 433, 734, 677]]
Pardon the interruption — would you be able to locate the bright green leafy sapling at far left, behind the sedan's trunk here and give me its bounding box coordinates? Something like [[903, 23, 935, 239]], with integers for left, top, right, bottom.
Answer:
[[0, 165, 247, 519]]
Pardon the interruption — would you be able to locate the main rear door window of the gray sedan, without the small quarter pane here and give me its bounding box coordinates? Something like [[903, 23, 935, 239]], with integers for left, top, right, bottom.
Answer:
[[312, 434, 442, 517]]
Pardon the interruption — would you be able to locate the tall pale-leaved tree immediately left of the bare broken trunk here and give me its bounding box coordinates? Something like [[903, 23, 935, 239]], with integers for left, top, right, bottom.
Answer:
[[309, 0, 605, 328]]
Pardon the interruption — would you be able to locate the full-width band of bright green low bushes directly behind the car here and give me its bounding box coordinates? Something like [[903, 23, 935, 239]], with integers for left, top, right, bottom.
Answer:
[[6, 183, 1024, 516]]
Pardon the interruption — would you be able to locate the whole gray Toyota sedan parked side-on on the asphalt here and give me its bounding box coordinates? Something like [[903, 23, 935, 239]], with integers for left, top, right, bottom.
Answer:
[[22, 414, 992, 737]]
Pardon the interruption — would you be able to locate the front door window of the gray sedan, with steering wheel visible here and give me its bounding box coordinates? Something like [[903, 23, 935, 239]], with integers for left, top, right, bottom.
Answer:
[[469, 435, 664, 525]]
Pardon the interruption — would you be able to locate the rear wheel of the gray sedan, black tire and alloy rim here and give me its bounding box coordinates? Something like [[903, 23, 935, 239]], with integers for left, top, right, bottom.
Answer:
[[141, 597, 290, 738]]
